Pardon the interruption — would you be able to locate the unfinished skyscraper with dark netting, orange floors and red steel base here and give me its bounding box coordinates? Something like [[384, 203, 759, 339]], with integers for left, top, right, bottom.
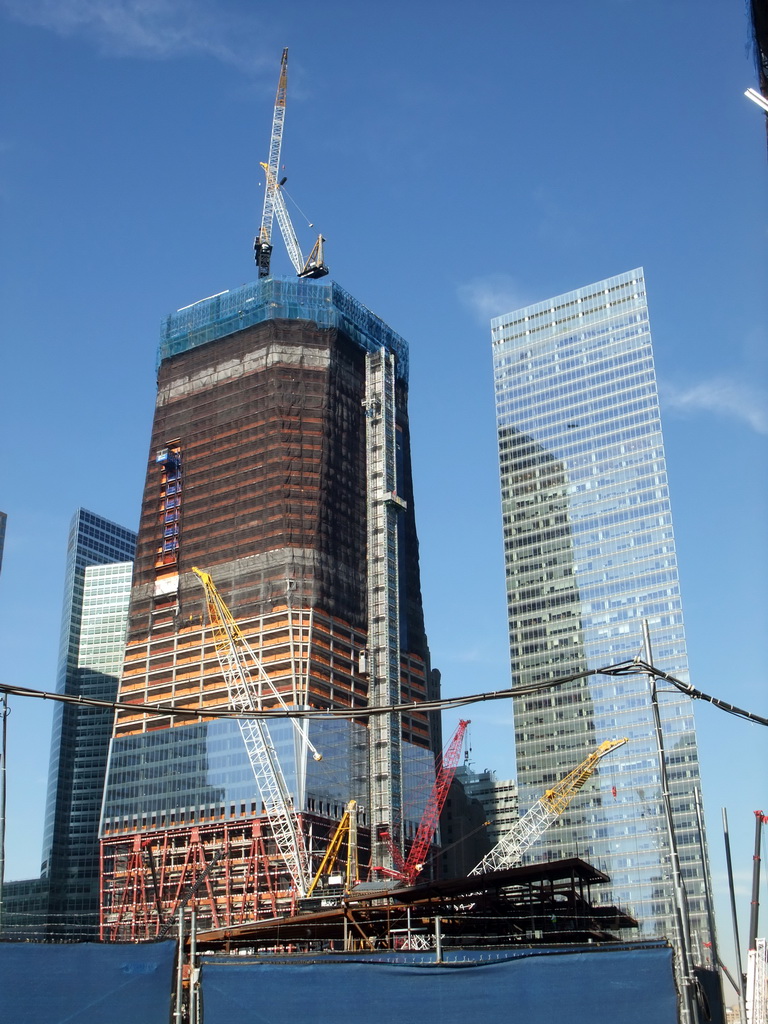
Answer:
[[101, 276, 439, 938]]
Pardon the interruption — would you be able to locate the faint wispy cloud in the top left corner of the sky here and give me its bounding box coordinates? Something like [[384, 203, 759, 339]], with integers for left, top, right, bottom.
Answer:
[[0, 0, 258, 70]]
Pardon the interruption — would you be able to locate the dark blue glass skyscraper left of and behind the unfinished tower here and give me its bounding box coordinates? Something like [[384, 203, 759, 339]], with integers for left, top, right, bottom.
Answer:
[[41, 509, 136, 939]]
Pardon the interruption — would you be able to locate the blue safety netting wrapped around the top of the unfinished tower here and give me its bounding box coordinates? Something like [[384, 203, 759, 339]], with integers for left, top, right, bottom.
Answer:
[[158, 278, 408, 381]]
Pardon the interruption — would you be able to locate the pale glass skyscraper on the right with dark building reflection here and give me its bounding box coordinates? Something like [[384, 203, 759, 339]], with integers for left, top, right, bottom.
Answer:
[[492, 269, 709, 963]]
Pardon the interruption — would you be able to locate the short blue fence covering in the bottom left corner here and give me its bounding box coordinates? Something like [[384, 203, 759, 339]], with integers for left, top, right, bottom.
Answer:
[[0, 942, 176, 1024]]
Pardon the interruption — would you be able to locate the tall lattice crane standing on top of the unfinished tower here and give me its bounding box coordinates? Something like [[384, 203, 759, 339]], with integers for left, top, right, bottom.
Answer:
[[253, 47, 328, 278]]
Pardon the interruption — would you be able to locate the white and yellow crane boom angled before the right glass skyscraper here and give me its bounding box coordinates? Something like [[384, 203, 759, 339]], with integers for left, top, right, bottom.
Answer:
[[469, 736, 628, 874]]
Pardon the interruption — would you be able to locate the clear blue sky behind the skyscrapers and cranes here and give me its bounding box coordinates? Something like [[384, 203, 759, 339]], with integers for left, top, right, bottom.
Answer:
[[0, 0, 768, 983]]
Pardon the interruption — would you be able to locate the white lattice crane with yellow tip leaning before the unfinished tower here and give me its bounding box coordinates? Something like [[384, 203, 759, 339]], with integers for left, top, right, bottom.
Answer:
[[193, 567, 322, 896]]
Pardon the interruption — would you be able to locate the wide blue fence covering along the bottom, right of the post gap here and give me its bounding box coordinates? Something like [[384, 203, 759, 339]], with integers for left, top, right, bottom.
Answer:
[[202, 943, 678, 1024]]
